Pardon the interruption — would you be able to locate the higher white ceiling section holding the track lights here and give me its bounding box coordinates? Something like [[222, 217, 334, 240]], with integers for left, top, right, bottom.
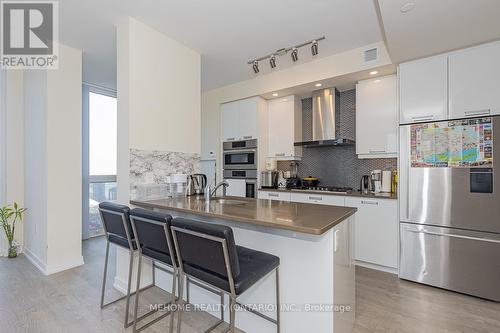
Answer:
[[59, 0, 382, 90]]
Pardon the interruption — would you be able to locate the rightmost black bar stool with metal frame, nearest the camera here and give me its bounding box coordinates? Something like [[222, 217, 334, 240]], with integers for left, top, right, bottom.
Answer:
[[171, 218, 280, 333]]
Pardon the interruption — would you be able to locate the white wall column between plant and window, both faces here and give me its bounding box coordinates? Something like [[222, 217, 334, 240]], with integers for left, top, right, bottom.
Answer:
[[24, 45, 83, 274]]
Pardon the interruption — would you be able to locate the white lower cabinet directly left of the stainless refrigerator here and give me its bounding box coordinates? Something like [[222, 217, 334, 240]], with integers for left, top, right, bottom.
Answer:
[[345, 197, 398, 268]]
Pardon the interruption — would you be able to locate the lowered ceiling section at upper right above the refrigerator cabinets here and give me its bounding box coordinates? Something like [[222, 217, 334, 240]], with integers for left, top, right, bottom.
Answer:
[[378, 0, 500, 63]]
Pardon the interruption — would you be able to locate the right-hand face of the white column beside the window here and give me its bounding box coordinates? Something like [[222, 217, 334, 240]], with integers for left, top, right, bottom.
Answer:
[[46, 45, 83, 271]]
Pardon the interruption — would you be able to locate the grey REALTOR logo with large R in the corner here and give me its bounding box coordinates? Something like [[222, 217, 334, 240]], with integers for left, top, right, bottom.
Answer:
[[0, 1, 59, 69]]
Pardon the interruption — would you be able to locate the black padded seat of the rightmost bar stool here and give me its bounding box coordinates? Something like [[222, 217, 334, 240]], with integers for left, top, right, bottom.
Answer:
[[184, 246, 280, 295]]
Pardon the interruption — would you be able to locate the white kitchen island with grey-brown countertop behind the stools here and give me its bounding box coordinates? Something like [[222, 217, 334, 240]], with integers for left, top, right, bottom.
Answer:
[[131, 197, 356, 333]]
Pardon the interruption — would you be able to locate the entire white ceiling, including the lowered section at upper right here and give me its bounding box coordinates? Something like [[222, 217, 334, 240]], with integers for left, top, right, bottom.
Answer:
[[59, 0, 500, 90]]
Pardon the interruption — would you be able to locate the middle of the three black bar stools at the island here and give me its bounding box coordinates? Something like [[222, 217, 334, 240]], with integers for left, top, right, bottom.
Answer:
[[130, 208, 178, 332]]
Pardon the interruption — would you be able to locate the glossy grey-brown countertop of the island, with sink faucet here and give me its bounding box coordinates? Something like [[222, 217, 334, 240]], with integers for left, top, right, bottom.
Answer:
[[130, 196, 357, 235]]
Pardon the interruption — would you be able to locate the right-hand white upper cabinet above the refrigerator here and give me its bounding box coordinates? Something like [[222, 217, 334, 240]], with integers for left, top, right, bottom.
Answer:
[[448, 43, 500, 118]]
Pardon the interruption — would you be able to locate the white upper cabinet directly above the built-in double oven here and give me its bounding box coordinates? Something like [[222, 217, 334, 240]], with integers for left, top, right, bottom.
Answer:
[[221, 97, 265, 141]]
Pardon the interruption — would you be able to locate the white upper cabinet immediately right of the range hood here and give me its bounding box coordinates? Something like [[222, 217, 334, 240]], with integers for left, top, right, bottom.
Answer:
[[356, 75, 398, 158]]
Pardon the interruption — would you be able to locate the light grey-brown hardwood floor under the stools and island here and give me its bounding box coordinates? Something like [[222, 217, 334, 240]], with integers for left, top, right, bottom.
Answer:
[[0, 238, 500, 333]]
